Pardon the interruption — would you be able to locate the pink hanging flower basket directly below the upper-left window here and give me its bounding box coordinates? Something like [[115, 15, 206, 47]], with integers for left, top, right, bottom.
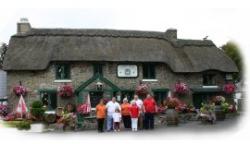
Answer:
[[58, 84, 74, 98]]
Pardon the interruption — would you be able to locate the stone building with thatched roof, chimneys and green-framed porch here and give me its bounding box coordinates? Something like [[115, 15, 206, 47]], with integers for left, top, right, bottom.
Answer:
[[3, 21, 238, 109]]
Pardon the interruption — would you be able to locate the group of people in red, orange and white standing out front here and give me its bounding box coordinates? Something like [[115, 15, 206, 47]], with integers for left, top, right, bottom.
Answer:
[[96, 94, 157, 132]]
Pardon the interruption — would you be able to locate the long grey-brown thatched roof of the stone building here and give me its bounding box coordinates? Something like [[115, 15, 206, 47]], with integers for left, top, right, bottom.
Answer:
[[4, 28, 238, 72]]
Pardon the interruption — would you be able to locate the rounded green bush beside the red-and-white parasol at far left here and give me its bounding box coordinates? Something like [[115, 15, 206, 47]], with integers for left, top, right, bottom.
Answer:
[[30, 101, 45, 118]]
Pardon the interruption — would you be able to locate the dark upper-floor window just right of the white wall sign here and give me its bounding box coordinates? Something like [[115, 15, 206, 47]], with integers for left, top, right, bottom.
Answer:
[[142, 64, 155, 79]]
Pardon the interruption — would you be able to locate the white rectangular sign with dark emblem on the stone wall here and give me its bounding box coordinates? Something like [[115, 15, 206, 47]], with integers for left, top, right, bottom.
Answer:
[[117, 65, 138, 77]]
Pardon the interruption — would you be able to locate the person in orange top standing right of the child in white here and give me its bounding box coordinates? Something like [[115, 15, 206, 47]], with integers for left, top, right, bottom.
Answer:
[[121, 98, 131, 128]]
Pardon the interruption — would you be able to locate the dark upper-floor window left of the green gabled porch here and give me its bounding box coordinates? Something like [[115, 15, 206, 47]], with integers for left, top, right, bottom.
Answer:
[[56, 64, 70, 80]]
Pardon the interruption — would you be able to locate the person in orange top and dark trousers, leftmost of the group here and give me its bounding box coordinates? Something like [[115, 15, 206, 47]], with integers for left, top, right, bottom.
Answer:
[[96, 99, 106, 132]]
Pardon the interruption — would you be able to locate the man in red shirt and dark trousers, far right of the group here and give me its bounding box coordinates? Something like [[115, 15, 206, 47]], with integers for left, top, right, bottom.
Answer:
[[143, 94, 157, 129]]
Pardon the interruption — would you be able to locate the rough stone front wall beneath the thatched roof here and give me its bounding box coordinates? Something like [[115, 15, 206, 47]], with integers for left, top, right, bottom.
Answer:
[[7, 62, 224, 110]]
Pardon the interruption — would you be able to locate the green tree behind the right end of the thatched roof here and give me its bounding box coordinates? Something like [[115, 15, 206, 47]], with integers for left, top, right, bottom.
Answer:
[[221, 41, 243, 81]]
